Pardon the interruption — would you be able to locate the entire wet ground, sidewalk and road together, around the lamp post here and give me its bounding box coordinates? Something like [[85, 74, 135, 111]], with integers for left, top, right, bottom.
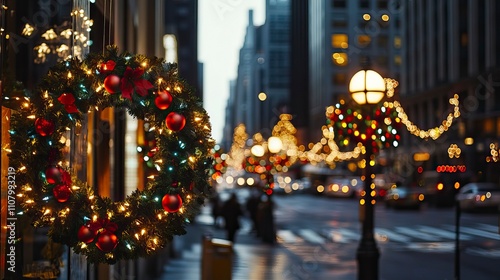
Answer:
[[160, 194, 500, 280]]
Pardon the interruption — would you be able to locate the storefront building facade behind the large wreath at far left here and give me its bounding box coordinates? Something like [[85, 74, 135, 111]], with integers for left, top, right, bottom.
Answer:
[[0, 0, 202, 279]]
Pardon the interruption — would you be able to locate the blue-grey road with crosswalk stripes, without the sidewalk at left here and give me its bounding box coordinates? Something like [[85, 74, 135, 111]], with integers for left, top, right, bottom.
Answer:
[[275, 195, 500, 280]]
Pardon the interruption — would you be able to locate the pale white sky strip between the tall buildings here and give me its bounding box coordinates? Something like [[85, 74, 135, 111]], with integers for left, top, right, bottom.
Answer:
[[198, 0, 266, 142]]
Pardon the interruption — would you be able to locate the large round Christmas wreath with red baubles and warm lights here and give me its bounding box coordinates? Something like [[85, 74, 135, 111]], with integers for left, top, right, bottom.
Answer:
[[2, 46, 214, 263]]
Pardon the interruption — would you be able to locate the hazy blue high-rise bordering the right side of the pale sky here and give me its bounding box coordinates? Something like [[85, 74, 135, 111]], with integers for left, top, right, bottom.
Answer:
[[223, 0, 290, 142]]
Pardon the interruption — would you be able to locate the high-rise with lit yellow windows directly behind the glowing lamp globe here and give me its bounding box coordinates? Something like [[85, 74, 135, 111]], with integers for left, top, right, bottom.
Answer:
[[308, 0, 401, 141]]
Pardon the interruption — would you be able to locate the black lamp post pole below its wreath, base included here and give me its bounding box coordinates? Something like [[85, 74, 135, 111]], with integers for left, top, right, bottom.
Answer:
[[356, 140, 380, 280]]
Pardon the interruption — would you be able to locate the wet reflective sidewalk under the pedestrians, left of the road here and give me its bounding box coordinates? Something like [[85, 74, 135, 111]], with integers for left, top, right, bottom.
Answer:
[[156, 203, 356, 280]]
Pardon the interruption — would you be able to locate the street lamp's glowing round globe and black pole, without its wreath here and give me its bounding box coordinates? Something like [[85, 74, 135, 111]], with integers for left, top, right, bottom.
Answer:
[[349, 70, 386, 280]]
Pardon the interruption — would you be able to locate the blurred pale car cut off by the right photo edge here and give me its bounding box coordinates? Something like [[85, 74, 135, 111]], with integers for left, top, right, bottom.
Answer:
[[456, 182, 500, 210]]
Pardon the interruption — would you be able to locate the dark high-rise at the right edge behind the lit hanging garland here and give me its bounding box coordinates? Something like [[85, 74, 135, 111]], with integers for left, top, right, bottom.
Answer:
[[400, 0, 500, 181]]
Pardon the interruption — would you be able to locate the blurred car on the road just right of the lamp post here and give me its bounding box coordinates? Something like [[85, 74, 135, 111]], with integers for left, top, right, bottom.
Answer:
[[384, 186, 425, 209]]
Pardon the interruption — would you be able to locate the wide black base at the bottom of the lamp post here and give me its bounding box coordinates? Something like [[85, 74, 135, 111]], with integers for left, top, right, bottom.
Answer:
[[356, 241, 380, 280]]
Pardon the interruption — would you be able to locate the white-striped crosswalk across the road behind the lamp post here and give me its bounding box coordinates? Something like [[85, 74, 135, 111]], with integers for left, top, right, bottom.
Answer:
[[277, 223, 500, 244]]
